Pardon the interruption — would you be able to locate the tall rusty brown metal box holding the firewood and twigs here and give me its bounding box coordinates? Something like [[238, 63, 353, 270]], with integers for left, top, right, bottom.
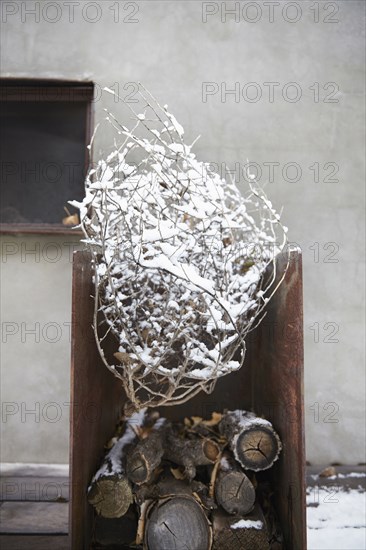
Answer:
[[70, 251, 306, 550]]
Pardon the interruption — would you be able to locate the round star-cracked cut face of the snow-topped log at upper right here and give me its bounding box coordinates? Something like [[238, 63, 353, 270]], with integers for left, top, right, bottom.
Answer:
[[234, 425, 281, 472]]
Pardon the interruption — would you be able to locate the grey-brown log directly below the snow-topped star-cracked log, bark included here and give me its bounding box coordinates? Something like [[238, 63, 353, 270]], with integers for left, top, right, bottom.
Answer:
[[215, 453, 255, 515]]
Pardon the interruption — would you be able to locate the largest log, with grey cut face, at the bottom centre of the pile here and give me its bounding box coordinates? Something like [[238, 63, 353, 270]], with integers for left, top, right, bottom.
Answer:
[[144, 494, 212, 550]]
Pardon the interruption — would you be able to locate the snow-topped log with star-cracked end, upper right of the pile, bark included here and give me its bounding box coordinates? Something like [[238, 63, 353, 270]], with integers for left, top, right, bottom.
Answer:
[[219, 410, 282, 472]]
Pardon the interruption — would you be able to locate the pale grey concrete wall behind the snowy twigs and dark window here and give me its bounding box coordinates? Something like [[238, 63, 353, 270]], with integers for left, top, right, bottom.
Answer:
[[1, 0, 365, 463]]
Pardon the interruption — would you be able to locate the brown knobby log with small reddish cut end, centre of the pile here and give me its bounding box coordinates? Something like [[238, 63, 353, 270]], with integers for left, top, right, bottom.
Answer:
[[164, 430, 220, 480]]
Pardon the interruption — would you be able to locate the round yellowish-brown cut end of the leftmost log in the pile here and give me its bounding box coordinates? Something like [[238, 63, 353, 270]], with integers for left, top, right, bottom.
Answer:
[[88, 476, 133, 518]]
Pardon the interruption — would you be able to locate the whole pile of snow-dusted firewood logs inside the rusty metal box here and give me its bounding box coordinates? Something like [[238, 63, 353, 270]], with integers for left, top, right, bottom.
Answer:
[[88, 410, 281, 550]]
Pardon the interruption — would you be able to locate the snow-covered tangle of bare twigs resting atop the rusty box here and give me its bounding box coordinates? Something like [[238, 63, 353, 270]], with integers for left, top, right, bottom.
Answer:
[[72, 85, 286, 410]]
